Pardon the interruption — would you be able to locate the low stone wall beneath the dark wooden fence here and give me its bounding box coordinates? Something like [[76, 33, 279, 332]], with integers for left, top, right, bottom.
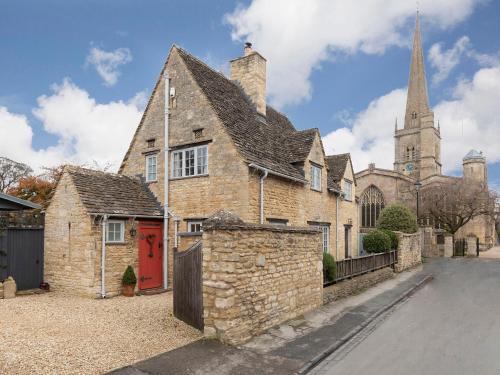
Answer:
[[323, 267, 394, 304]]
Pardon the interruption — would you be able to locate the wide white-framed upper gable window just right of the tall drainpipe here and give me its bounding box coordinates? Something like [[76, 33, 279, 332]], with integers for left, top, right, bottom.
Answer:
[[172, 145, 208, 178]]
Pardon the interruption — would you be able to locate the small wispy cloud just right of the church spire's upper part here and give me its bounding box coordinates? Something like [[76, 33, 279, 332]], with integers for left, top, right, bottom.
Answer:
[[429, 36, 470, 85]]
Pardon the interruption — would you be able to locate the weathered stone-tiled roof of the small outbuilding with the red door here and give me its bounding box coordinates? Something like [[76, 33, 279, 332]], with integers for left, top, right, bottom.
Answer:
[[65, 167, 162, 217]]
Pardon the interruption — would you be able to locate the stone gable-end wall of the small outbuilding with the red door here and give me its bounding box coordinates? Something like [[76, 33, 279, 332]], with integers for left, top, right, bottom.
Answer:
[[44, 173, 96, 296]]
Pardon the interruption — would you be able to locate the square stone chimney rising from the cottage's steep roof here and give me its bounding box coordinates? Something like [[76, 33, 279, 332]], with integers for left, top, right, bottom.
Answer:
[[231, 42, 266, 116]]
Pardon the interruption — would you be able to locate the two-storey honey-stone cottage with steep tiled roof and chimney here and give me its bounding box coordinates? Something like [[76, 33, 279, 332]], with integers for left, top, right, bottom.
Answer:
[[46, 43, 358, 296]]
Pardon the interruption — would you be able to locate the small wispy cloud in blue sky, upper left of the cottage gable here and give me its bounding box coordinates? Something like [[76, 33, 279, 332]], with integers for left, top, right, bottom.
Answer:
[[86, 47, 132, 86]]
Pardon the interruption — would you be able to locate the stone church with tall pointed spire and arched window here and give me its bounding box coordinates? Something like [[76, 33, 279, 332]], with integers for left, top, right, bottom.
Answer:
[[356, 14, 495, 255]]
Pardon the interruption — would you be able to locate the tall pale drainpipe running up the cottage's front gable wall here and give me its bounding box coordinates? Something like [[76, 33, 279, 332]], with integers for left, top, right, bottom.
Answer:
[[163, 71, 170, 289]]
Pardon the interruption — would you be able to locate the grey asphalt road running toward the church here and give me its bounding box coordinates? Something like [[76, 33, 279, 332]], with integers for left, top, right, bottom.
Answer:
[[311, 258, 500, 375]]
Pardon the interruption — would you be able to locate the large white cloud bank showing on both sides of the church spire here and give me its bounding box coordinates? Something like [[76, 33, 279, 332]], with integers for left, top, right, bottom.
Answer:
[[323, 64, 500, 173]]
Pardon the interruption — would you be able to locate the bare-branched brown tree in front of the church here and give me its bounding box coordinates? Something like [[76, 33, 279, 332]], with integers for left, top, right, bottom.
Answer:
[[422, 179, 495, 235]]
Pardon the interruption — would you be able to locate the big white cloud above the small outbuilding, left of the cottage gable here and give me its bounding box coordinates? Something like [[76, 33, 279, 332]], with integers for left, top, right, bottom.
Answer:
[[0, 79, 145, 170]]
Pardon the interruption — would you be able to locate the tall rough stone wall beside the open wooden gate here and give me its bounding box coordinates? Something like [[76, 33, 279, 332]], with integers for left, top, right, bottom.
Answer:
[[203, 214, 323, 345]]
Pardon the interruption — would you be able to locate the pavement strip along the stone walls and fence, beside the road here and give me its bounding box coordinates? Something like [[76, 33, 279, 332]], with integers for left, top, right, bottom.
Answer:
[[108, 267, 430, 375]]
